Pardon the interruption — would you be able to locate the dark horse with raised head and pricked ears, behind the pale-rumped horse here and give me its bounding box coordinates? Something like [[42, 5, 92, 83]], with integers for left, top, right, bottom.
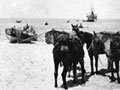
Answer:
[[71, 24, 98, 75]]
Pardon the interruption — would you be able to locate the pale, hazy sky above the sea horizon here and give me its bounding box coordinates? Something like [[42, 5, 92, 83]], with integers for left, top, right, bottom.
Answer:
[[0, 0, 120, 19]]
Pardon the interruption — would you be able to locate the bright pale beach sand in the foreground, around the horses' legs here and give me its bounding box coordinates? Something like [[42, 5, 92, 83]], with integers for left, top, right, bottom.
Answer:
[[0, 41, 120, 90]]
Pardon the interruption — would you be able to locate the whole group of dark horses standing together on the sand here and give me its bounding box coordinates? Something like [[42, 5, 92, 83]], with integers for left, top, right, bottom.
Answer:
[[45, 24, 120, 89]]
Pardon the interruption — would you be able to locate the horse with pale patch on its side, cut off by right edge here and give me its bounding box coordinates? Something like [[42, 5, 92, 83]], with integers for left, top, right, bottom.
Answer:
[[92, 32, 120, 83]]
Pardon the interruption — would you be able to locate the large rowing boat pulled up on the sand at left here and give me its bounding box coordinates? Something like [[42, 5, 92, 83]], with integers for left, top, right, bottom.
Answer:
[[5, 27, 37, 43]]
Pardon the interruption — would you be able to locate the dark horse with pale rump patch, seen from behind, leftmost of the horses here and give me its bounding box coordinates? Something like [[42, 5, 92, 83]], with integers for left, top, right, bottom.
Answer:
[[45, 30, 85, 89]]
